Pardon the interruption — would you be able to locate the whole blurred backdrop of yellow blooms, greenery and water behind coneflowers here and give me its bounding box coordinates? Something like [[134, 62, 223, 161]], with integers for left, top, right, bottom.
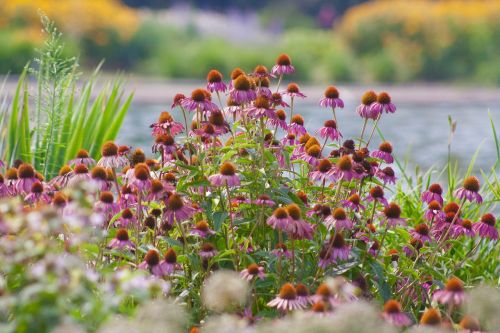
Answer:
[[0, 0, 500, 167]]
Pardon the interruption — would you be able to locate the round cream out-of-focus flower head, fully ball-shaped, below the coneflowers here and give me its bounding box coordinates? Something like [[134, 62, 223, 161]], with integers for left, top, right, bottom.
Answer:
[[202, 271, 248, 312]]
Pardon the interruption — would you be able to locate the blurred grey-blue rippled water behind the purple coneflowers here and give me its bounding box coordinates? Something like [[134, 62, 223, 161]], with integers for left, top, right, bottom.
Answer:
[[118, 101, 500, 173]]
